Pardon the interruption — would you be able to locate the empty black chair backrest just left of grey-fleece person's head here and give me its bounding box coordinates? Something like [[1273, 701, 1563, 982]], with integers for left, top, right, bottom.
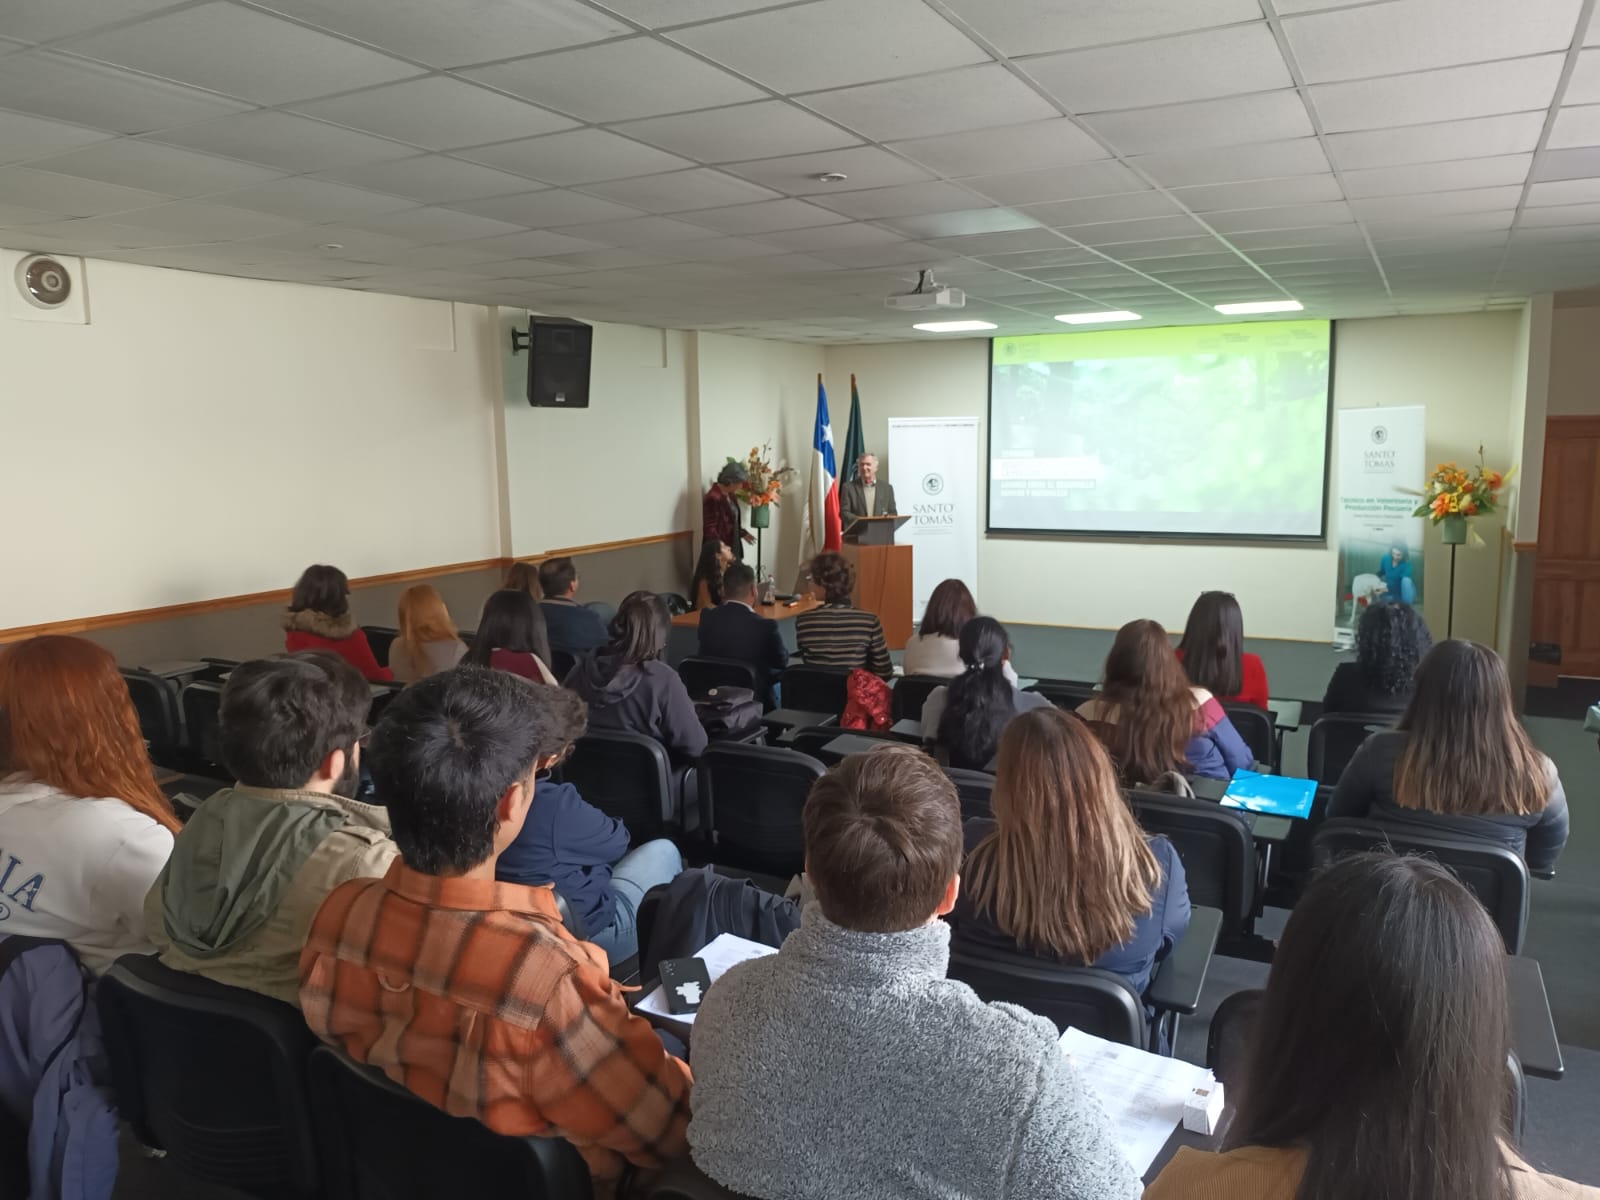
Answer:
[[699, 742, 837, 877]]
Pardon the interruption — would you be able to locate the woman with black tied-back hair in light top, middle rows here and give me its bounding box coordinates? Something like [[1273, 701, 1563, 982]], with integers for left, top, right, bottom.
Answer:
[[922, 616, 1051, 771]]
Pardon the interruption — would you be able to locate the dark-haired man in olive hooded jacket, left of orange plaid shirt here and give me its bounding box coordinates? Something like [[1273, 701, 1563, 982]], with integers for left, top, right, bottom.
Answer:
[[144, 653, 395, 1005]]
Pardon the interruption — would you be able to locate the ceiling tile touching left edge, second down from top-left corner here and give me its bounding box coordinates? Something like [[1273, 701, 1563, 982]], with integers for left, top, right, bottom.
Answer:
[[0, 51, 246, 133]]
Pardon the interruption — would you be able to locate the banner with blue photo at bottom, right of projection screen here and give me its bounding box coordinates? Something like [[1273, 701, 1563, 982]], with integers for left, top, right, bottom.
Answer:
[[1333, 405, 1427, 650]]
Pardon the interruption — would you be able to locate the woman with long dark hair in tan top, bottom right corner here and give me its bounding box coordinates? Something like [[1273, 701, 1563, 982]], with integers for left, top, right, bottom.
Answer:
[[1145, 854, 1600, 1200]]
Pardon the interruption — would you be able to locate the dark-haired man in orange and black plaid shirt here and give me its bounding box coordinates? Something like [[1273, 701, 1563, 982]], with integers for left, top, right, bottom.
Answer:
[[299, 667, 690, 1200]]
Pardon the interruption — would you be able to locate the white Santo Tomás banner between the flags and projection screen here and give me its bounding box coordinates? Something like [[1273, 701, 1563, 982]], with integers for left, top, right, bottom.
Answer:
[[888, 416, 979, 621]]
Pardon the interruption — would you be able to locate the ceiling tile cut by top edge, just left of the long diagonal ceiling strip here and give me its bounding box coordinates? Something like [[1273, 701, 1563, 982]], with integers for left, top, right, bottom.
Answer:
[[946, 0, 1261, 56]]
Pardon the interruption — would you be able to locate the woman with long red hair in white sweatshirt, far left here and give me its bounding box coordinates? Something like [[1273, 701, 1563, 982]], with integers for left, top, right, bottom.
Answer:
[[0, 637, 179, 974]]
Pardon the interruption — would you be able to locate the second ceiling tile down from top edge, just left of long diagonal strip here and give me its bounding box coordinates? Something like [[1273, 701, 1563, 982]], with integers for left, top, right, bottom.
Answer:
[[1019, 21, 1294, 112]]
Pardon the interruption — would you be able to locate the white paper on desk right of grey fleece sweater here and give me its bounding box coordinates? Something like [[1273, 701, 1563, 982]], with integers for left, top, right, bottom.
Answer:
[[1061, 1029, 1211, 1174]]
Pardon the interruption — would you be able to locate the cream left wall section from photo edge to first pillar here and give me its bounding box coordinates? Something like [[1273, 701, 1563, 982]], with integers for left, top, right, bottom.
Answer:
[[0, 261, 499, 629]]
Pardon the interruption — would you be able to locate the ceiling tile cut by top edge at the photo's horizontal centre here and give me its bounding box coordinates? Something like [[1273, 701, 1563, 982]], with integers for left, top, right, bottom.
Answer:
[[672, 0, 989, 93]]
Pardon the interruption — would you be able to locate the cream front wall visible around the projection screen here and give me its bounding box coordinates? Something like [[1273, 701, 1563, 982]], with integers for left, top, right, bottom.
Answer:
[[827, 312, 1520, 642]]
